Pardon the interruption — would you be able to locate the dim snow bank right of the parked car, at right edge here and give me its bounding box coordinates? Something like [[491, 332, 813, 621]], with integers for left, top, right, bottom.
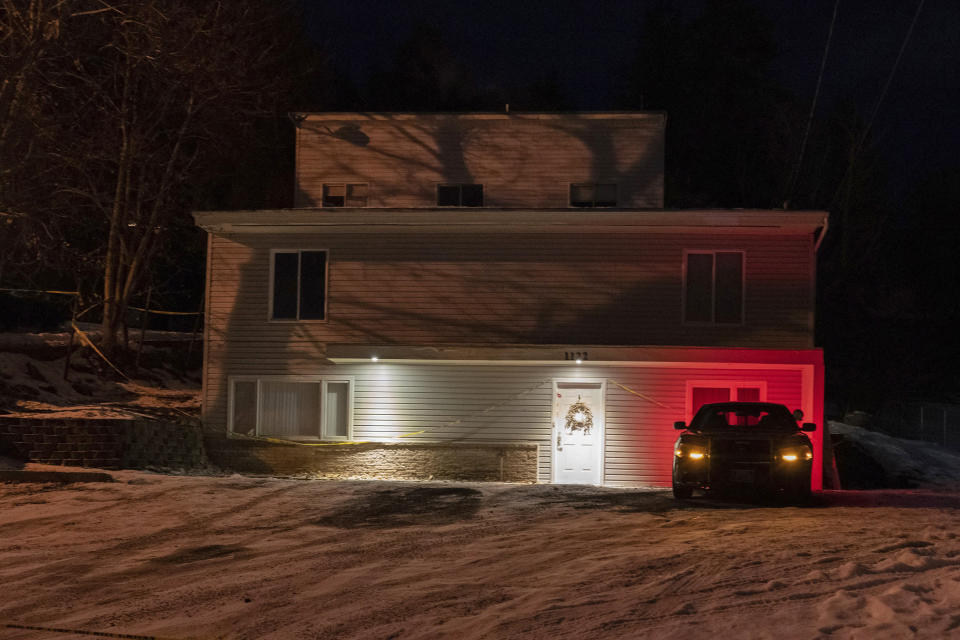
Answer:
[[828, 422, 960, 489]]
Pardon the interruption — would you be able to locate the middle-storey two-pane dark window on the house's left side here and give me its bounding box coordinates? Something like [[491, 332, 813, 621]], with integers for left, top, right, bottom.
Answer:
[[270, 249, 327, 320]]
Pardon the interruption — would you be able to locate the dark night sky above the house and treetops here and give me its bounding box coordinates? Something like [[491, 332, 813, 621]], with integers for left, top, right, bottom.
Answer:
[[304, 0, 960, 200]]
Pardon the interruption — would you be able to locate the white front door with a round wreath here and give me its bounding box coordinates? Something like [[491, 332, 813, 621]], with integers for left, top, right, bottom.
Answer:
[[553, 381, 604, 484]]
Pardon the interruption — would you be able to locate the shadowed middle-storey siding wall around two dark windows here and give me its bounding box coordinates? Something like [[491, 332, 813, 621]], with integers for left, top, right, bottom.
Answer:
[[207, 232, 814, 352]]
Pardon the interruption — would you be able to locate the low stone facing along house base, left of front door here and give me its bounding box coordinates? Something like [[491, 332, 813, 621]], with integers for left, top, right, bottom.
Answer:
[[205, 433, 537, 483]]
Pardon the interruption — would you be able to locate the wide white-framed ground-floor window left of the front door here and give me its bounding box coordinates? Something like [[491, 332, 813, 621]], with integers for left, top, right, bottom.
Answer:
[[230, 376, 353, 440]]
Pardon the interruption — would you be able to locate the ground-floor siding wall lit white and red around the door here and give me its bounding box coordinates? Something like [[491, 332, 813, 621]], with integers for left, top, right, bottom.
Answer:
[[204, 358, 822, 488]]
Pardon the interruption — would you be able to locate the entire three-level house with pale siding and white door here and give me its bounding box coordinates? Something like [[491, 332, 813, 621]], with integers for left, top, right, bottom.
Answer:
[[196, 112, 827, 488]]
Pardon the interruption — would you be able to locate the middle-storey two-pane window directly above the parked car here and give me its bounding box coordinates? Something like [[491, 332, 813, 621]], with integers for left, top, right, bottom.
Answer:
[[683, 251, 744, 324]]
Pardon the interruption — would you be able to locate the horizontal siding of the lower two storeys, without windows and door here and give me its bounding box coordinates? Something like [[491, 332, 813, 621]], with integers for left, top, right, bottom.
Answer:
[[203, 232, 814, 485]]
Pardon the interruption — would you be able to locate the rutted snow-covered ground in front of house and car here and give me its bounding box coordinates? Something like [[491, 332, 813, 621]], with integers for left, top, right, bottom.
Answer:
[[0, 465, 960, 640]]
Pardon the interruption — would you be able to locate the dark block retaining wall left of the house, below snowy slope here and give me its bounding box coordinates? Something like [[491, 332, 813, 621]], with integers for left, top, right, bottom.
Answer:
[[0, 416, 207, 469]]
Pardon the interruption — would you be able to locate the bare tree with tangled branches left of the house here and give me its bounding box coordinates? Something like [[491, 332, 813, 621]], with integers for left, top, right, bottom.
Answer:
[[0, 0, 302, 349]]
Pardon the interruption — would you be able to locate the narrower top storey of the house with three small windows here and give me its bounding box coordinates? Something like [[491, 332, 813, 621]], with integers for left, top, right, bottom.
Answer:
[[293, 112, 666, 209]]
